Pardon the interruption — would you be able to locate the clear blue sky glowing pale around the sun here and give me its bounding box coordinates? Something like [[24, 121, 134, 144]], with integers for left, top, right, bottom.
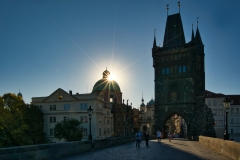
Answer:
[[0, 0, 240, 108]]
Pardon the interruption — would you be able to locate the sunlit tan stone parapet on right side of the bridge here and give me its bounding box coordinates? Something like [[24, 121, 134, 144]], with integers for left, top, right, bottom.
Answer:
[[199, 136, 240, 160]]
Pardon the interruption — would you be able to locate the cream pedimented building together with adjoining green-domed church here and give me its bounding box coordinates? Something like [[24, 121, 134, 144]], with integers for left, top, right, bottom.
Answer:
[[31, 69, 133, 143]]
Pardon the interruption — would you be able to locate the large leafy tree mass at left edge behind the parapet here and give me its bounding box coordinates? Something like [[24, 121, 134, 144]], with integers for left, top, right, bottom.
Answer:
[[0, 93, 45, 147]]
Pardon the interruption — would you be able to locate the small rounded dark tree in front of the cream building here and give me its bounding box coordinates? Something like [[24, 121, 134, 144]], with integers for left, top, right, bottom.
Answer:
[[54, 119, 83, 142]]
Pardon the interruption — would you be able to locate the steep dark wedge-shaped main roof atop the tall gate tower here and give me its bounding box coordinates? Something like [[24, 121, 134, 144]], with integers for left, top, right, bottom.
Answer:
[[163, 13, 186, 47]]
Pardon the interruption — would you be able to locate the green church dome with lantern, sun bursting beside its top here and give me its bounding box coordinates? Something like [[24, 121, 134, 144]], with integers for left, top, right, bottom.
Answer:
[[92, 69, 121, 93]]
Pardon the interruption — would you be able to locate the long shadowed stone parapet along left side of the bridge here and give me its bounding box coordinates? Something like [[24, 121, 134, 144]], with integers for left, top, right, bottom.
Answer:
[[0, 136, 135, 160]]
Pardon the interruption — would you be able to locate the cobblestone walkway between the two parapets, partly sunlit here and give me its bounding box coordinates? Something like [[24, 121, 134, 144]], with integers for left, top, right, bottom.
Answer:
[[61, 139, 229, 160]]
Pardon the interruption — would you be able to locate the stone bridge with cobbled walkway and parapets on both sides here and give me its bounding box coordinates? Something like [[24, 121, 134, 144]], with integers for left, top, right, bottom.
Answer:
[[0, 136, 240, 160]]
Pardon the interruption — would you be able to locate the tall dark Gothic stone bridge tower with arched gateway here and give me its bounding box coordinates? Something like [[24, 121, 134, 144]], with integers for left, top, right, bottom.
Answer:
[[152, 5, 215, 139]]
